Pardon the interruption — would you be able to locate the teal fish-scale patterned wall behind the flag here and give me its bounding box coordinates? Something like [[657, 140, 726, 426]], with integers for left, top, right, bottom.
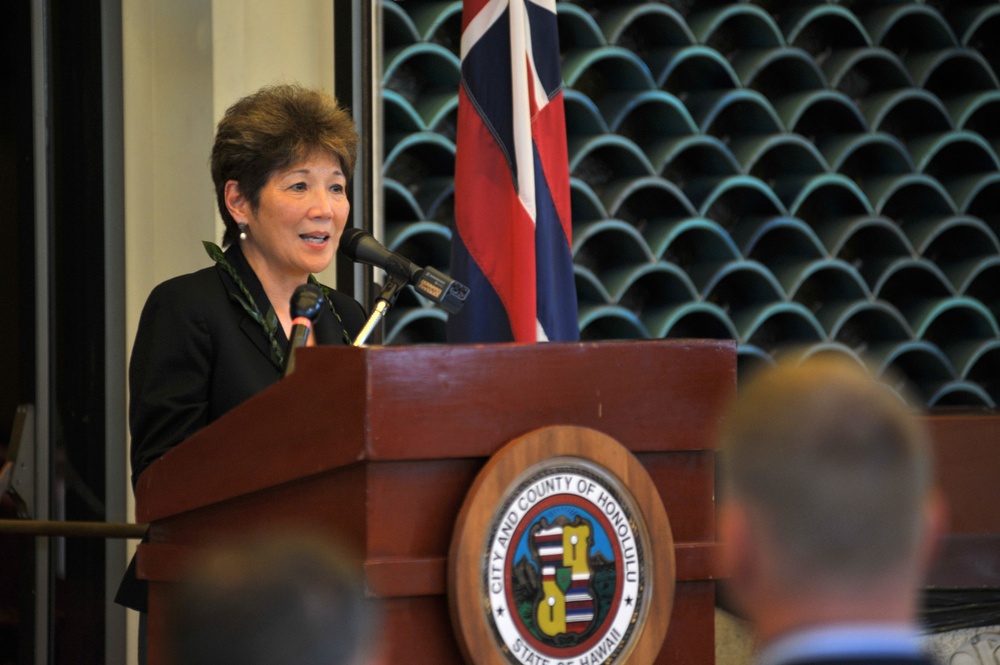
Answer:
[[383, 0, 1000, 408]]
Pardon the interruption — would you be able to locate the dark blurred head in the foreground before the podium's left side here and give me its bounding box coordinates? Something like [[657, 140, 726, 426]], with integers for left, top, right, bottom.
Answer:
[[167, 534, 375, 665]]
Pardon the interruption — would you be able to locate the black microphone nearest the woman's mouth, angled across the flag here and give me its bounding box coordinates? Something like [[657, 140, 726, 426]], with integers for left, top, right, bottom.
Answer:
[[340, 228, 469, 314]]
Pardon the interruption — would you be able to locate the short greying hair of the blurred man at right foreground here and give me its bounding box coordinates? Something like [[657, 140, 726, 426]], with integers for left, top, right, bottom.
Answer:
[[720, 357, 933, 582]]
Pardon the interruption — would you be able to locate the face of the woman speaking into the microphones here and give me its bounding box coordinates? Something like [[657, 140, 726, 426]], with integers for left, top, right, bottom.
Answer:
[[226, 153, 351, 284]]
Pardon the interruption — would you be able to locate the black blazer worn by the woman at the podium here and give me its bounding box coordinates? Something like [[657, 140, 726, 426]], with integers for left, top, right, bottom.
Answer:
[[116, 244, 366, 609]]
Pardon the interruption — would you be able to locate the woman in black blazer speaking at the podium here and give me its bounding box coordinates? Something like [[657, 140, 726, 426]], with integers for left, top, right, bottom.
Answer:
[[116, 85, 365, 652]]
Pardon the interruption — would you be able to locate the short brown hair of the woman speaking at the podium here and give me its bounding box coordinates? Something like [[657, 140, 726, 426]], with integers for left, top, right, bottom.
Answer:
[[212, 85, 358, 246]]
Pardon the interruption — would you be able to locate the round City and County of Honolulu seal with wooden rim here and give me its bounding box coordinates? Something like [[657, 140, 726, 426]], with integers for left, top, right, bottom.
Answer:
[[448, 426, 674, 665]]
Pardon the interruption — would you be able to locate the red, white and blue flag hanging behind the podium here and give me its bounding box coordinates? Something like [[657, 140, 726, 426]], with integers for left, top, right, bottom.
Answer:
[[448, 0, 580, 342]]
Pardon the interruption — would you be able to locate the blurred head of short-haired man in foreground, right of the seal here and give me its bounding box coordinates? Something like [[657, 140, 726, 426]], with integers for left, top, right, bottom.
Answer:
[[720, 357, 943, 632]]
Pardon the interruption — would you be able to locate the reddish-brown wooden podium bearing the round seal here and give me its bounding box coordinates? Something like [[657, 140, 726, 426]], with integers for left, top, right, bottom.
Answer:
[[136, 340, 736, 665]]
